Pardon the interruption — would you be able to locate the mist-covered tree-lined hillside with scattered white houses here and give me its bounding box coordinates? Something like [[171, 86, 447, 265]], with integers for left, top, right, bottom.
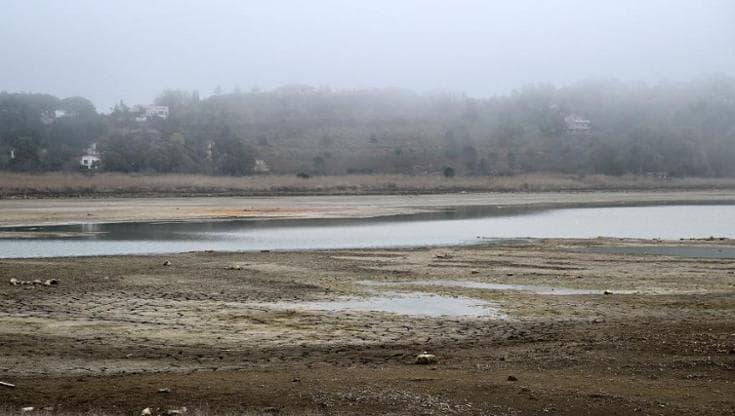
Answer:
[[0, 77, 735, 176]]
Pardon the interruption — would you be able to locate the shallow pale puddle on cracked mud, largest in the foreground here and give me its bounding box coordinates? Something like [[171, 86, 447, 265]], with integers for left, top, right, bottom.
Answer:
[[270, 293, 506, 319]]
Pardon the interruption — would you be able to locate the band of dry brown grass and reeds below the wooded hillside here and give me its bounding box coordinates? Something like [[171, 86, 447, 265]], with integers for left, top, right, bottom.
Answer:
[[0, 172, 735, 198]]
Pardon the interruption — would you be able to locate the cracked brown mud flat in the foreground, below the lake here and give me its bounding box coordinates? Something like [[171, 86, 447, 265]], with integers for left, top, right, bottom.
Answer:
[[0, 239, 735, 415]]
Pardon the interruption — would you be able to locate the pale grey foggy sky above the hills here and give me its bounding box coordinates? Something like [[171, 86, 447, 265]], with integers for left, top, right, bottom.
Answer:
[[0, 0, 735, 111]]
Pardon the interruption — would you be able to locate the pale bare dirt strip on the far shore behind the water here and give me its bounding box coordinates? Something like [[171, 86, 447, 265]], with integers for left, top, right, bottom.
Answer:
[[0, 190, 735, 226]]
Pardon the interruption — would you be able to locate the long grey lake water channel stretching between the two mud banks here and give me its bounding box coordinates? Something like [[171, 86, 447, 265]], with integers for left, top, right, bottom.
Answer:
[[0, 205, 735, 258]]
